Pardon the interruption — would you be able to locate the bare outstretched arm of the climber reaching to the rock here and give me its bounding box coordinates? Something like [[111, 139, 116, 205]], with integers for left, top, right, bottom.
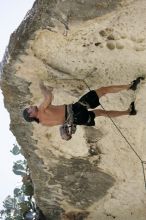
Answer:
[[40, 82, 53, 108]]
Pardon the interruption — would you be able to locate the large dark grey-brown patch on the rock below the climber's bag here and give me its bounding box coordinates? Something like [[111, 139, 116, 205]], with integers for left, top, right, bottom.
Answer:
[[49, 158, 115, 209]]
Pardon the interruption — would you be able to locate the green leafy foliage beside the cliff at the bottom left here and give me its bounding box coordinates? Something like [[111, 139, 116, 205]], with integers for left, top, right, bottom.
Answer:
[[0, 145, 45, 220]]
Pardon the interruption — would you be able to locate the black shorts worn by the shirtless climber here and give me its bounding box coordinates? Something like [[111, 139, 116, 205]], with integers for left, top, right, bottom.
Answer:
[[72, 90, 100, 126]]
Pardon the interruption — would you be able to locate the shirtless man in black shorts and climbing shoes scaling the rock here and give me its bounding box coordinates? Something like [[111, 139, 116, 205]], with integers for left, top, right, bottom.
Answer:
[[23, 77, 144, 126]]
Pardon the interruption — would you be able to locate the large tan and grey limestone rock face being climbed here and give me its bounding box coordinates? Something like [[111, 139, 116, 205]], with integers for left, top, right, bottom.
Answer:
[[1, 0, 146, 220]]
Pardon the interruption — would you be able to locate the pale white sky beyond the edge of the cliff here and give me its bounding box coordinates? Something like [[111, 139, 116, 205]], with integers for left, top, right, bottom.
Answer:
[[0, 0, 34, 209]]
